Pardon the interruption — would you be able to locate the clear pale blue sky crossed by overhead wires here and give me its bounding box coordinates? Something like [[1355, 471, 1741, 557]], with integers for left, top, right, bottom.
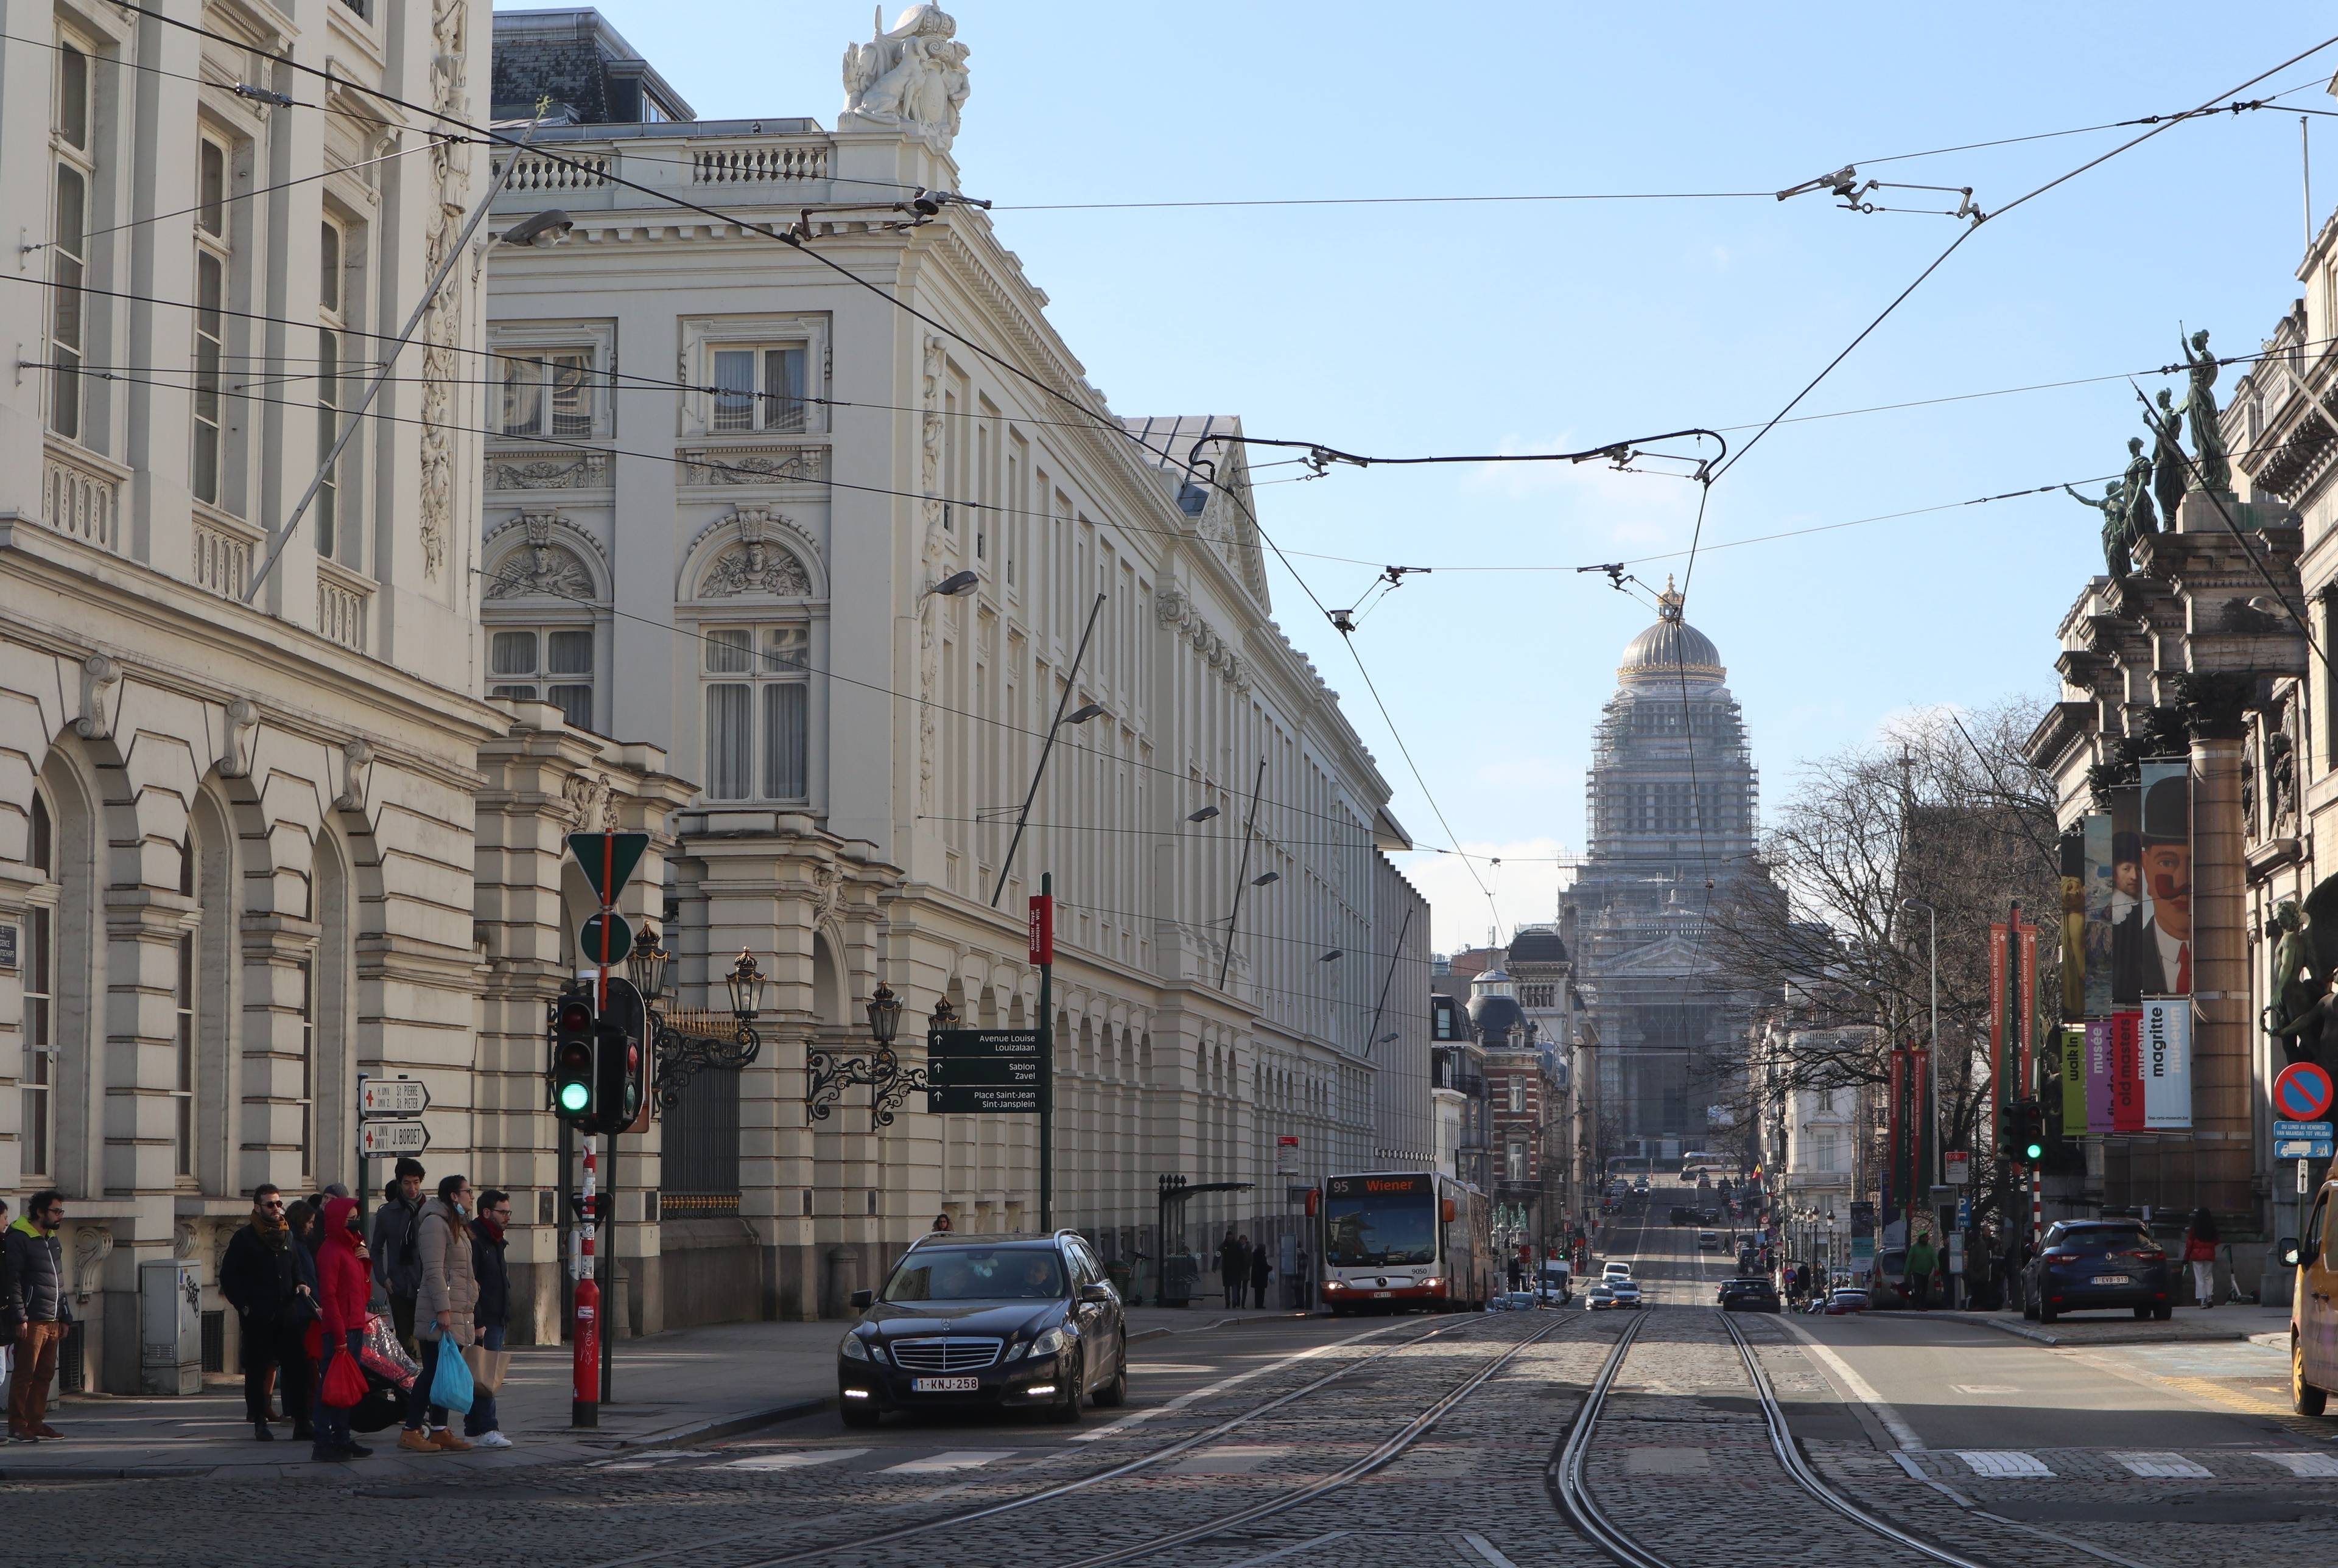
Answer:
[[512, 0, 2338, 949]]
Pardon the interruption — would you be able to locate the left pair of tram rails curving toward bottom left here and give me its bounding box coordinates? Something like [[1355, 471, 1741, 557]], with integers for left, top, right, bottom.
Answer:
[[592, 1315, 1569, 1568]]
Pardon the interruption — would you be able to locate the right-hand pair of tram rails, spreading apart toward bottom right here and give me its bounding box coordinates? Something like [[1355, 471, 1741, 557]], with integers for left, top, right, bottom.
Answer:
[[1548, 1309, 1992, 1568]]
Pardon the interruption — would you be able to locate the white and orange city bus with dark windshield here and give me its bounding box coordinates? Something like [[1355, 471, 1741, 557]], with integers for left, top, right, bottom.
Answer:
[[1319, 1171, 1498, 1314]]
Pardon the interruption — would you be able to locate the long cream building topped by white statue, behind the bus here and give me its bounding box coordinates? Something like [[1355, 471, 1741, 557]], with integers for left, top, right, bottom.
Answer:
[[477, 7, 1436, 1325]]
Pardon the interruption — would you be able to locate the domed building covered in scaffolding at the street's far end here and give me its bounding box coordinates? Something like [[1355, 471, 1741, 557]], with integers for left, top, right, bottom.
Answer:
[[1562, 587, 1758, 1157]]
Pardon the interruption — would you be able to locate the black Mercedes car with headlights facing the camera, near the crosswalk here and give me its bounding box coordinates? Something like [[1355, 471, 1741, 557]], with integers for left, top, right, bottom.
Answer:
[[837, 1231, 1129, 1426]]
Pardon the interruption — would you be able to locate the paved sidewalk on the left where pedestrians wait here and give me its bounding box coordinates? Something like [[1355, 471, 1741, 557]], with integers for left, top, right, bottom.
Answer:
[[0, 1306, 1305, 1482]]
